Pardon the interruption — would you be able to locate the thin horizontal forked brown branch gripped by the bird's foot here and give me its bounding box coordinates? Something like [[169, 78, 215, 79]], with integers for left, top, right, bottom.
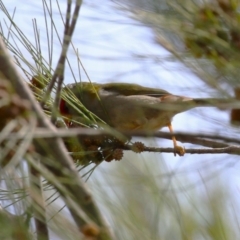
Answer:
[[7, 128, 240, 155]]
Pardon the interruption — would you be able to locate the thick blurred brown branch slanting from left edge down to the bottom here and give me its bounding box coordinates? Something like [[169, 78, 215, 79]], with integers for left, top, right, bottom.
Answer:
[[0, 34, 113, 239]]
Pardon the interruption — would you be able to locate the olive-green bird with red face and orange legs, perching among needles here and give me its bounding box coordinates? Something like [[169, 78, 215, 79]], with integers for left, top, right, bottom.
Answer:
[[59, 82, 237, 155]]
